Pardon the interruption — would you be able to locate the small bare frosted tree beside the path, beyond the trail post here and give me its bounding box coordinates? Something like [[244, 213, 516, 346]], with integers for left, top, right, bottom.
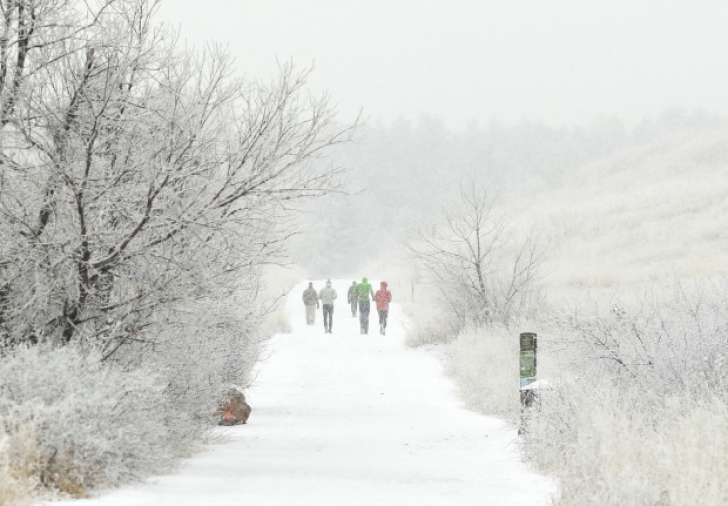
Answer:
[[409, 177, 544, 325]]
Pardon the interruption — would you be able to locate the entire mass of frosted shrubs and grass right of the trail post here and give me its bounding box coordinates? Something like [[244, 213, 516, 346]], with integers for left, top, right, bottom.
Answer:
[[524, 284, 728, 506]]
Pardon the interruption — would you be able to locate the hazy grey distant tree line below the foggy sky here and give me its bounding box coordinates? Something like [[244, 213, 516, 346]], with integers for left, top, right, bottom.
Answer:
[[293, 108, 728, 276]]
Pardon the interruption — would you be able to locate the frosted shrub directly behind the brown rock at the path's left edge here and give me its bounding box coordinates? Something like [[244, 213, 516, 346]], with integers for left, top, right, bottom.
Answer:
[[106, 294, 264, 440]]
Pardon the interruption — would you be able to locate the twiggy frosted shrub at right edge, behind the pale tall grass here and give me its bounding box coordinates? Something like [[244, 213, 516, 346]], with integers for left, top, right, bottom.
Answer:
[[557, 284, 728, 401]]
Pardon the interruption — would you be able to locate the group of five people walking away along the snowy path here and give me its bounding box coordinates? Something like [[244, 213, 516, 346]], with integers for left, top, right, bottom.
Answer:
[[303, 278, 392, 335]]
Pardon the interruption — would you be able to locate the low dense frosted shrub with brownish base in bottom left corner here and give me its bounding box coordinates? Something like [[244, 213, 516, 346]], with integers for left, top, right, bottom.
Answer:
[[0, 347, 176, 496]]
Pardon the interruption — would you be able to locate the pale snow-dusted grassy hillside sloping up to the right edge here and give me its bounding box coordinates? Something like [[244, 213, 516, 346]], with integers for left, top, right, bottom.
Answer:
[[514, 129, 728, 300]]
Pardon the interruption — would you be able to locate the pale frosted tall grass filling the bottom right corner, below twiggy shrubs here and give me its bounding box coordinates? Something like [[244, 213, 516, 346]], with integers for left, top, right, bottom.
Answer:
[[524, 385, 728, 506]]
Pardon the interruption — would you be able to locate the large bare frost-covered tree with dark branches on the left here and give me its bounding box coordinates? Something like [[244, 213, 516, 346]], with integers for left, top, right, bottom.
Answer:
[[0, 0, 351, 359]]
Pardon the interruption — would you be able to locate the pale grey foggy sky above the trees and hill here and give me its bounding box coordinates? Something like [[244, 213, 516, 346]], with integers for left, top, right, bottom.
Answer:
[[159, 0, 728, 128]]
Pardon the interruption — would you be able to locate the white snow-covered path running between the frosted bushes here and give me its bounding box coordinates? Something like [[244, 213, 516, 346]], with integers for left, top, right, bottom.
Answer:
[[45, 281, 555, 506]]
